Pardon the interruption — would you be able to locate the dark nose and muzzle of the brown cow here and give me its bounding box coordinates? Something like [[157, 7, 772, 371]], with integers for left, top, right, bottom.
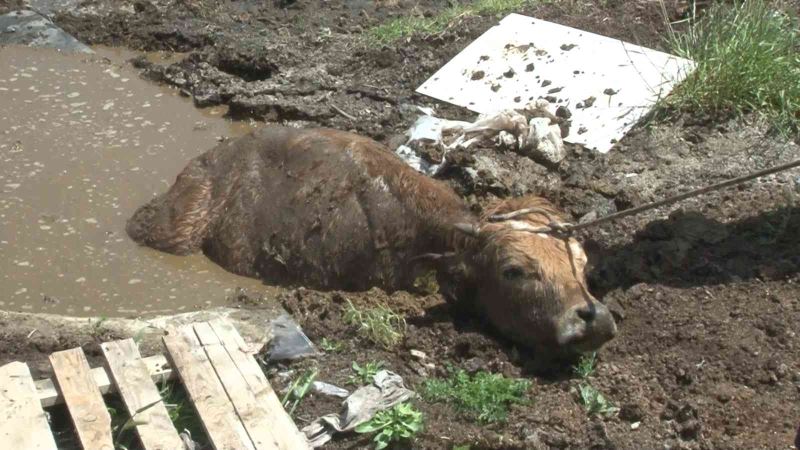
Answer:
[[557, 301, 617, 352]]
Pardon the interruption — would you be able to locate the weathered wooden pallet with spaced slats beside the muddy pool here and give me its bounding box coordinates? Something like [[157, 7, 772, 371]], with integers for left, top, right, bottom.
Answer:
[[0, 319, 310, 450]]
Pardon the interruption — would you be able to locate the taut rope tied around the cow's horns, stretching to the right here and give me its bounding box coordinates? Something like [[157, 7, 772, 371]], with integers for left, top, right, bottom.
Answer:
[[489, 159, 800, 236]]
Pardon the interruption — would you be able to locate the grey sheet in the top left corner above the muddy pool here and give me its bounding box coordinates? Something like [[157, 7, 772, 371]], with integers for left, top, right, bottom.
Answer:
[[0, 10, 94, 53]]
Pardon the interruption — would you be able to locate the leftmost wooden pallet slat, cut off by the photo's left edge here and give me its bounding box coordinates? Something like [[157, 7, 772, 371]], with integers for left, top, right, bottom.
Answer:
[[0, 362, 56, 450]]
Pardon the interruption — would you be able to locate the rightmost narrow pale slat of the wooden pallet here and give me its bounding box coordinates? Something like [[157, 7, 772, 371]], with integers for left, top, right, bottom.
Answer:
[[209, 319, 310, 450]]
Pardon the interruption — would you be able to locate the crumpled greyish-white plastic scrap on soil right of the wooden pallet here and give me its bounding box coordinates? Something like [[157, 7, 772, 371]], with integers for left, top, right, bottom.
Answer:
[[301, 370, 414, 448]]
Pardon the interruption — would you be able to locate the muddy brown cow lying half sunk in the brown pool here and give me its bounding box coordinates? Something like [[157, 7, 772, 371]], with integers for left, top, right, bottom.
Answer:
[[126, 126, 617, 353]]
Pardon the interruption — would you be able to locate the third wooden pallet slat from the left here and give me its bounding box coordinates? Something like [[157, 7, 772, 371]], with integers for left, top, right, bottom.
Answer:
[[100, 339, 184, 450]]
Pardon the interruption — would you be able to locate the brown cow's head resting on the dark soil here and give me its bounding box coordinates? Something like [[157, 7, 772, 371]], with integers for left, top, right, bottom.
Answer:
[[440, 199, 617, 353]]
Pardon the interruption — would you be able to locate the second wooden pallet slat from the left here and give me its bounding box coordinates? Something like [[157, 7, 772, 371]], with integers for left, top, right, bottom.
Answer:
[[50, 347, 114, 450]]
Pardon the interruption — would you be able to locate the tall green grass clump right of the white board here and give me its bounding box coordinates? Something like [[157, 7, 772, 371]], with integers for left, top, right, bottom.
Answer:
[[661, 0, 800, 133]]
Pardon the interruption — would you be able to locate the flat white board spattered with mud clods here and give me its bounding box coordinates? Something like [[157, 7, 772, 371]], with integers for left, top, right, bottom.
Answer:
[[417, 14, 694, 153]]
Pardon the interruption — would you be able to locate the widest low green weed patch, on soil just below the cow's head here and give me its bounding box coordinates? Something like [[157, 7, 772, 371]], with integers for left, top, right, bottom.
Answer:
[[422, 370, 531, 423]]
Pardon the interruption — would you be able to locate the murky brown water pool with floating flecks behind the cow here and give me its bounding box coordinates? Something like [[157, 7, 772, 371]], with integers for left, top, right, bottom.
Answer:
[[0, 47, 262, 315]]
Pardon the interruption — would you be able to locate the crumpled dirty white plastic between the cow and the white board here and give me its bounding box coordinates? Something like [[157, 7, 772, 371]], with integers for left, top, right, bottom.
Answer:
[[396, 99, 566, 175]]
